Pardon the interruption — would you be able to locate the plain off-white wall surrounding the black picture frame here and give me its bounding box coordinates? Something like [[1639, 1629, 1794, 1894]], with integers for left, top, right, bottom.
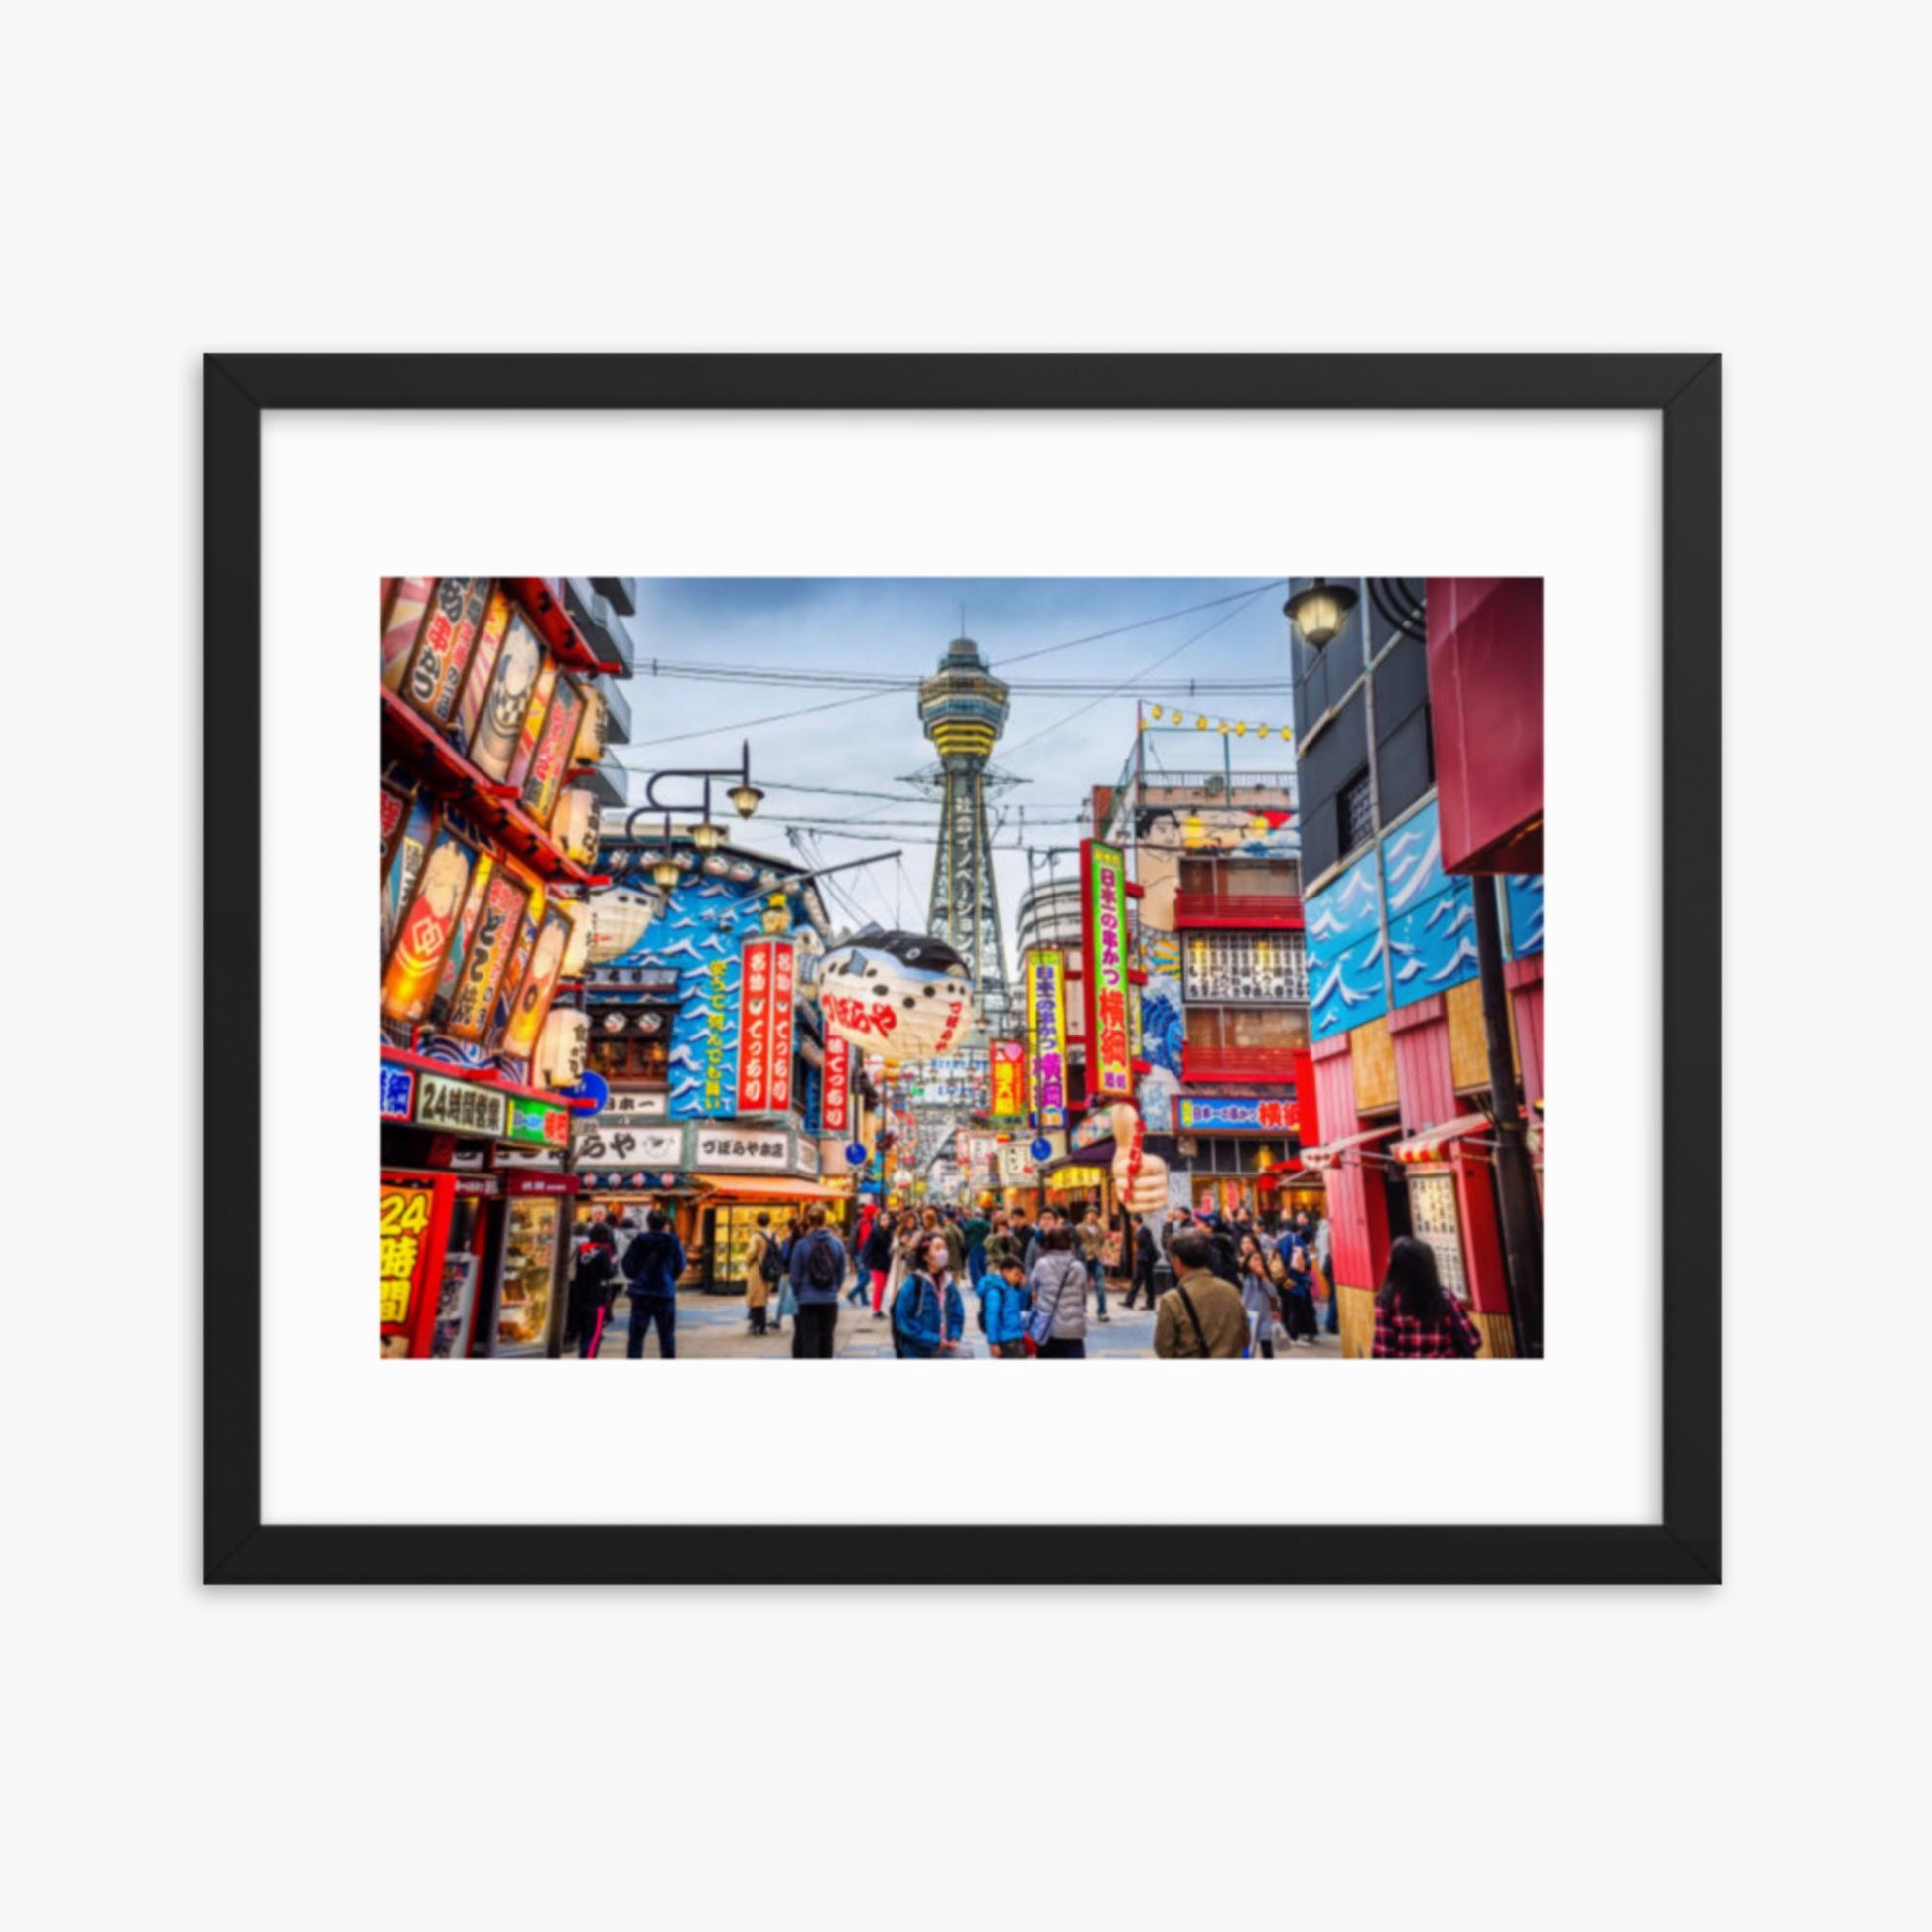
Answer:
[[11, 4, 1928, 1928]]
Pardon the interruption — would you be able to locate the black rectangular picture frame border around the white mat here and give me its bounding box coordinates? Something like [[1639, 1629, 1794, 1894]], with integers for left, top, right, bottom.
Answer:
[[201, 353, 1722, 1583]]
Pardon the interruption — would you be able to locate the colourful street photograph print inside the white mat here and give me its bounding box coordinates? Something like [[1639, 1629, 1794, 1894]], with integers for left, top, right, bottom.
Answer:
[[371, 572, 1546, 1364]]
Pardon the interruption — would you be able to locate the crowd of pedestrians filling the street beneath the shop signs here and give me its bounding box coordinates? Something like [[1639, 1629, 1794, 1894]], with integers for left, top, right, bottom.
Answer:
[[566, 1181, 1480, 1362]]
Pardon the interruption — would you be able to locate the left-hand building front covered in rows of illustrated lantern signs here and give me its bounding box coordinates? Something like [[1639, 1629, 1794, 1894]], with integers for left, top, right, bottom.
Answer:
[[380, 578, 629, 1358]]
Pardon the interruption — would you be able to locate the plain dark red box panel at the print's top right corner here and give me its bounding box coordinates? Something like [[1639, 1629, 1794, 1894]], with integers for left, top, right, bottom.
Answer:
[[1428, 578, 1544, 872]]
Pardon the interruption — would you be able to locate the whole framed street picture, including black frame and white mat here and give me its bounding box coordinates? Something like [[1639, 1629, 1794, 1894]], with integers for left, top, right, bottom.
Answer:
[[203, 355, 1722, 1583]]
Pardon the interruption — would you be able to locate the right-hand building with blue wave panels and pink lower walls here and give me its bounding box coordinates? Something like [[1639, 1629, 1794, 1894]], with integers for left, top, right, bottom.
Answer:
[[1291, 578, 1544, 1356]]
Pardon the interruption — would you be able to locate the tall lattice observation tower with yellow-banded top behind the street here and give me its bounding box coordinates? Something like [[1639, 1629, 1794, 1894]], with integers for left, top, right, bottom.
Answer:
[[919, 637, 1013, 1032]]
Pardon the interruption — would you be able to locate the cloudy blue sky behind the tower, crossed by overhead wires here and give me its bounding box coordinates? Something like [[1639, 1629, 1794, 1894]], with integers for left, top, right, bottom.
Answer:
[[619, 566, 1291, 968]]
